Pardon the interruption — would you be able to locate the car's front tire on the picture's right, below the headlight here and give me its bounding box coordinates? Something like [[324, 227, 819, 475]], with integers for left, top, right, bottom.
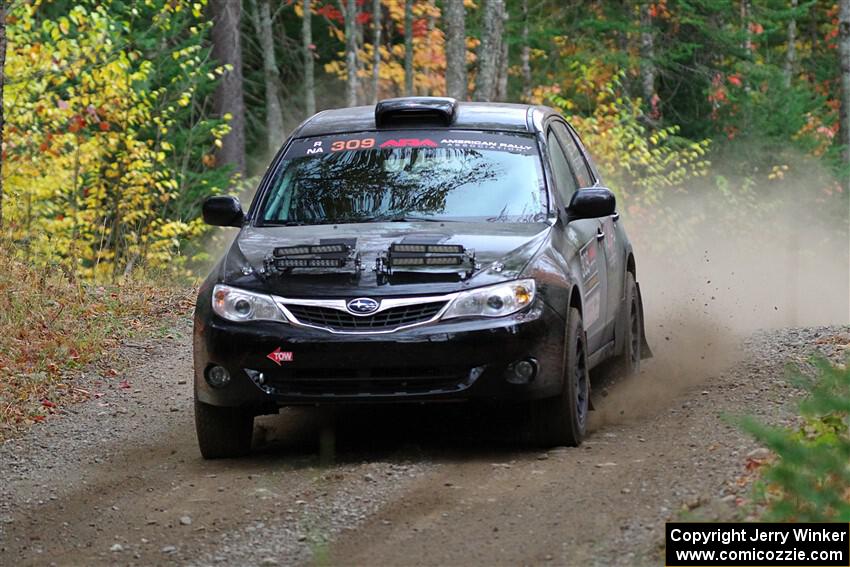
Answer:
[[531, 307, 590, 446]]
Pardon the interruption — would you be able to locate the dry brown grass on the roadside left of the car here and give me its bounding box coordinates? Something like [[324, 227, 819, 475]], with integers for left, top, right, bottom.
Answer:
[[0, 249, 194, 441]]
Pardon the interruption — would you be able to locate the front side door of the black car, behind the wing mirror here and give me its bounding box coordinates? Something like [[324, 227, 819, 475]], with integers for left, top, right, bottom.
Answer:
[[546, 120, 608, 352]]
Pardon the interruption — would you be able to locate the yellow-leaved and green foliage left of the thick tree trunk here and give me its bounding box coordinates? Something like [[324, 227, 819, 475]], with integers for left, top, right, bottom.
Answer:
[[3, 0, 227, 280]]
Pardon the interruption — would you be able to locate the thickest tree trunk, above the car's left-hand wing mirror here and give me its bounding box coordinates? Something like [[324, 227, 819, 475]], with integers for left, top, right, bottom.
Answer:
[[210, 0, 245, 176]]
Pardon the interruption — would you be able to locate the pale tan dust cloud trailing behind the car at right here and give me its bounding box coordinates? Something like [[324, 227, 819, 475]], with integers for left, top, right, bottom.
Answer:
[[592, 164, 850, 427]]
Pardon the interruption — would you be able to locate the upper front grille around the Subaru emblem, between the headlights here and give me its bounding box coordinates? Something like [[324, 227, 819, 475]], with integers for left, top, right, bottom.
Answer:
[[286, 301, 446, 332]]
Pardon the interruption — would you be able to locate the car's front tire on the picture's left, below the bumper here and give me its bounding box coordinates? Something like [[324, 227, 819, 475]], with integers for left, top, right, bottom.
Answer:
[[195, 400, 254, 459]]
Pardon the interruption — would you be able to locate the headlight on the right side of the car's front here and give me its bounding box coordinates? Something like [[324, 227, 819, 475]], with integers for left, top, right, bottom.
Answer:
[[443, 279, 536, 319]]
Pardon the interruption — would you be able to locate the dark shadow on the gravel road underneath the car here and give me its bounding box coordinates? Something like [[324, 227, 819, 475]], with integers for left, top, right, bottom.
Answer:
[[245, 368, 616, 465]]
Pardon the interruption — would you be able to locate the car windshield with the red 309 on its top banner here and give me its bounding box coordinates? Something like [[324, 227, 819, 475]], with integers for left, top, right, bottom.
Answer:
[[259, 131, 548, 225]]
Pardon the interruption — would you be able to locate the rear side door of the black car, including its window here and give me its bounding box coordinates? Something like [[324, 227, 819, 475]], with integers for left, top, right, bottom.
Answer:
[[555, 125, 626, 340]]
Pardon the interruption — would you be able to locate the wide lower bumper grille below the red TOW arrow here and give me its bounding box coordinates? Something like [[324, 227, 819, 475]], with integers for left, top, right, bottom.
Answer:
[[267, 367, 472, 396]]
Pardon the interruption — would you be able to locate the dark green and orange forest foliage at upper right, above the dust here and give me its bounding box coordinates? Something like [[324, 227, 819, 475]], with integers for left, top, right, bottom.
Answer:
[[509, 0, 845, 180]]
